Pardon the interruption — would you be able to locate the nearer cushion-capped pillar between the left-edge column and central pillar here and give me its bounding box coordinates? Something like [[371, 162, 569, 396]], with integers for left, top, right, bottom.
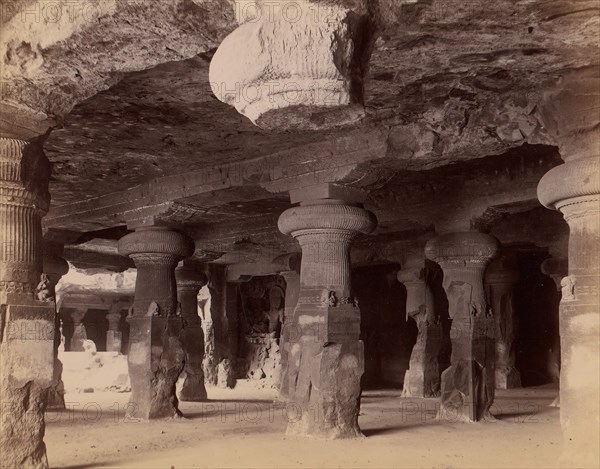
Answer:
[[118, 227, 194, 419]]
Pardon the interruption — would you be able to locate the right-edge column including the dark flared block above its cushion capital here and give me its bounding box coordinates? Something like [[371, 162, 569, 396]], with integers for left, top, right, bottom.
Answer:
[[538, 65, 600, 467]]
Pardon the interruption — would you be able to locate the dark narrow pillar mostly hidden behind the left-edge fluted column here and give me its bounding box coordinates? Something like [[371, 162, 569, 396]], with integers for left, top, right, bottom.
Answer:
[[43, 250, 69, 409]]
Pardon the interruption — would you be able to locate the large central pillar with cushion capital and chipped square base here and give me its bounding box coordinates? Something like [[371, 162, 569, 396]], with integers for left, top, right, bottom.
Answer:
[[279, 187, 376, 438]]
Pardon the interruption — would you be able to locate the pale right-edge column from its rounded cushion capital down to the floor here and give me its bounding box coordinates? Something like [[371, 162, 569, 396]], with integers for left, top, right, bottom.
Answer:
[[538, 156, 600, 467]]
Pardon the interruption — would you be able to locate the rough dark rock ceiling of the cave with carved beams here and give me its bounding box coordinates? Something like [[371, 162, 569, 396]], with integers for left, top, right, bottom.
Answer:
[[1, 0, 600, 266]]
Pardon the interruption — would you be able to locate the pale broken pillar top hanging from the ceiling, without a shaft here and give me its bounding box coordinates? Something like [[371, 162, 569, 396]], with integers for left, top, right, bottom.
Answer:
[[209, 0, 374, 130]]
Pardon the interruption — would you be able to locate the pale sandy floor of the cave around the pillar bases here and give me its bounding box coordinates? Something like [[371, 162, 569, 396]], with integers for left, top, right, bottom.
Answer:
[[45, 382, 560, 469]]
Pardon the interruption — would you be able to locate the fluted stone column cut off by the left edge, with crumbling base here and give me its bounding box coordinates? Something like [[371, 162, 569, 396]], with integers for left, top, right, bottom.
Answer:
[[0, 137, 56, 468]]
